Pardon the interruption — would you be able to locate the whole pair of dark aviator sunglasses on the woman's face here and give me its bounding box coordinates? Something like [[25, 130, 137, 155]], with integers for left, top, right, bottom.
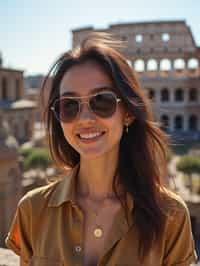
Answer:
[[50, 92, 121, 123]]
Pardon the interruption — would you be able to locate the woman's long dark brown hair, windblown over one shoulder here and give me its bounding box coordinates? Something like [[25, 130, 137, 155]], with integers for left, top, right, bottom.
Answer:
[[42, 33, 168, 259]]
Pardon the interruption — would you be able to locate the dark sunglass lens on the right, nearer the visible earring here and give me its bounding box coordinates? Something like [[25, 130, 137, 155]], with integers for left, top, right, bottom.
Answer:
[[90, 93, 116, 117]]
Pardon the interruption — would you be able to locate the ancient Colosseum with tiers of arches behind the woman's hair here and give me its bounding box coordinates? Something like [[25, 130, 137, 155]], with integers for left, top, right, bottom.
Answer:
[[72, 20, 200, 140]]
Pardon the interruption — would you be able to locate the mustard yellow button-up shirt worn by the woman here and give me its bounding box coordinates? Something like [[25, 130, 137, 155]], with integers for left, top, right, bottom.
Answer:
[[6, 167, 197, 266]]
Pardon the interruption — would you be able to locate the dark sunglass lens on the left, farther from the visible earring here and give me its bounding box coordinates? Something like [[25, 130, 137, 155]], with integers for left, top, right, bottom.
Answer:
[[55, 98, 79, 122]]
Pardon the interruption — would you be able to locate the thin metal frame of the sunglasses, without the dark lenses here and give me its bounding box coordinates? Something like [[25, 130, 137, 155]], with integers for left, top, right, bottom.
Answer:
[[50, 91, 122, 123]]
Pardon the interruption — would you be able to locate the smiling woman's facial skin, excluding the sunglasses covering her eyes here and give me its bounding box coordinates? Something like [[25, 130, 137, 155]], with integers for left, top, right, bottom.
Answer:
[[60, 61, 125, 158]]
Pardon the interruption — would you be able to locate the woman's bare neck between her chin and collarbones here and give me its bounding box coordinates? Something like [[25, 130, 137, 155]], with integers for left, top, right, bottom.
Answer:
[[77, 150, 123, 200]]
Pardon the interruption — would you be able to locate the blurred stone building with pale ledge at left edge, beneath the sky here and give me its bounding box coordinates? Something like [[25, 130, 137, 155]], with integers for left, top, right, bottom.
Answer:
[[0, 66, 36, 143]]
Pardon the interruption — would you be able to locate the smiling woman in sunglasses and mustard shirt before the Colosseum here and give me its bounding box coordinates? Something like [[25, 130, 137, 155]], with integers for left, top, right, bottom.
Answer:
[[6, 34, 196, 266]]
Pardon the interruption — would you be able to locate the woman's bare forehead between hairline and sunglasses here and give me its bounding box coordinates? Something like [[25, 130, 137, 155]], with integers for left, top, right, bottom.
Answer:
[[60, 61, 113, 95]]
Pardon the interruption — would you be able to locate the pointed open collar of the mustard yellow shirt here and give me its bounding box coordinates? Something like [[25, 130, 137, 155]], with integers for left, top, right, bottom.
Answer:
[[48, 164, 134, 212]]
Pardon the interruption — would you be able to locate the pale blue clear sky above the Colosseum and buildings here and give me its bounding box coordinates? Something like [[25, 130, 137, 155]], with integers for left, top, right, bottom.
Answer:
[[0, 0, 200, 75]]
